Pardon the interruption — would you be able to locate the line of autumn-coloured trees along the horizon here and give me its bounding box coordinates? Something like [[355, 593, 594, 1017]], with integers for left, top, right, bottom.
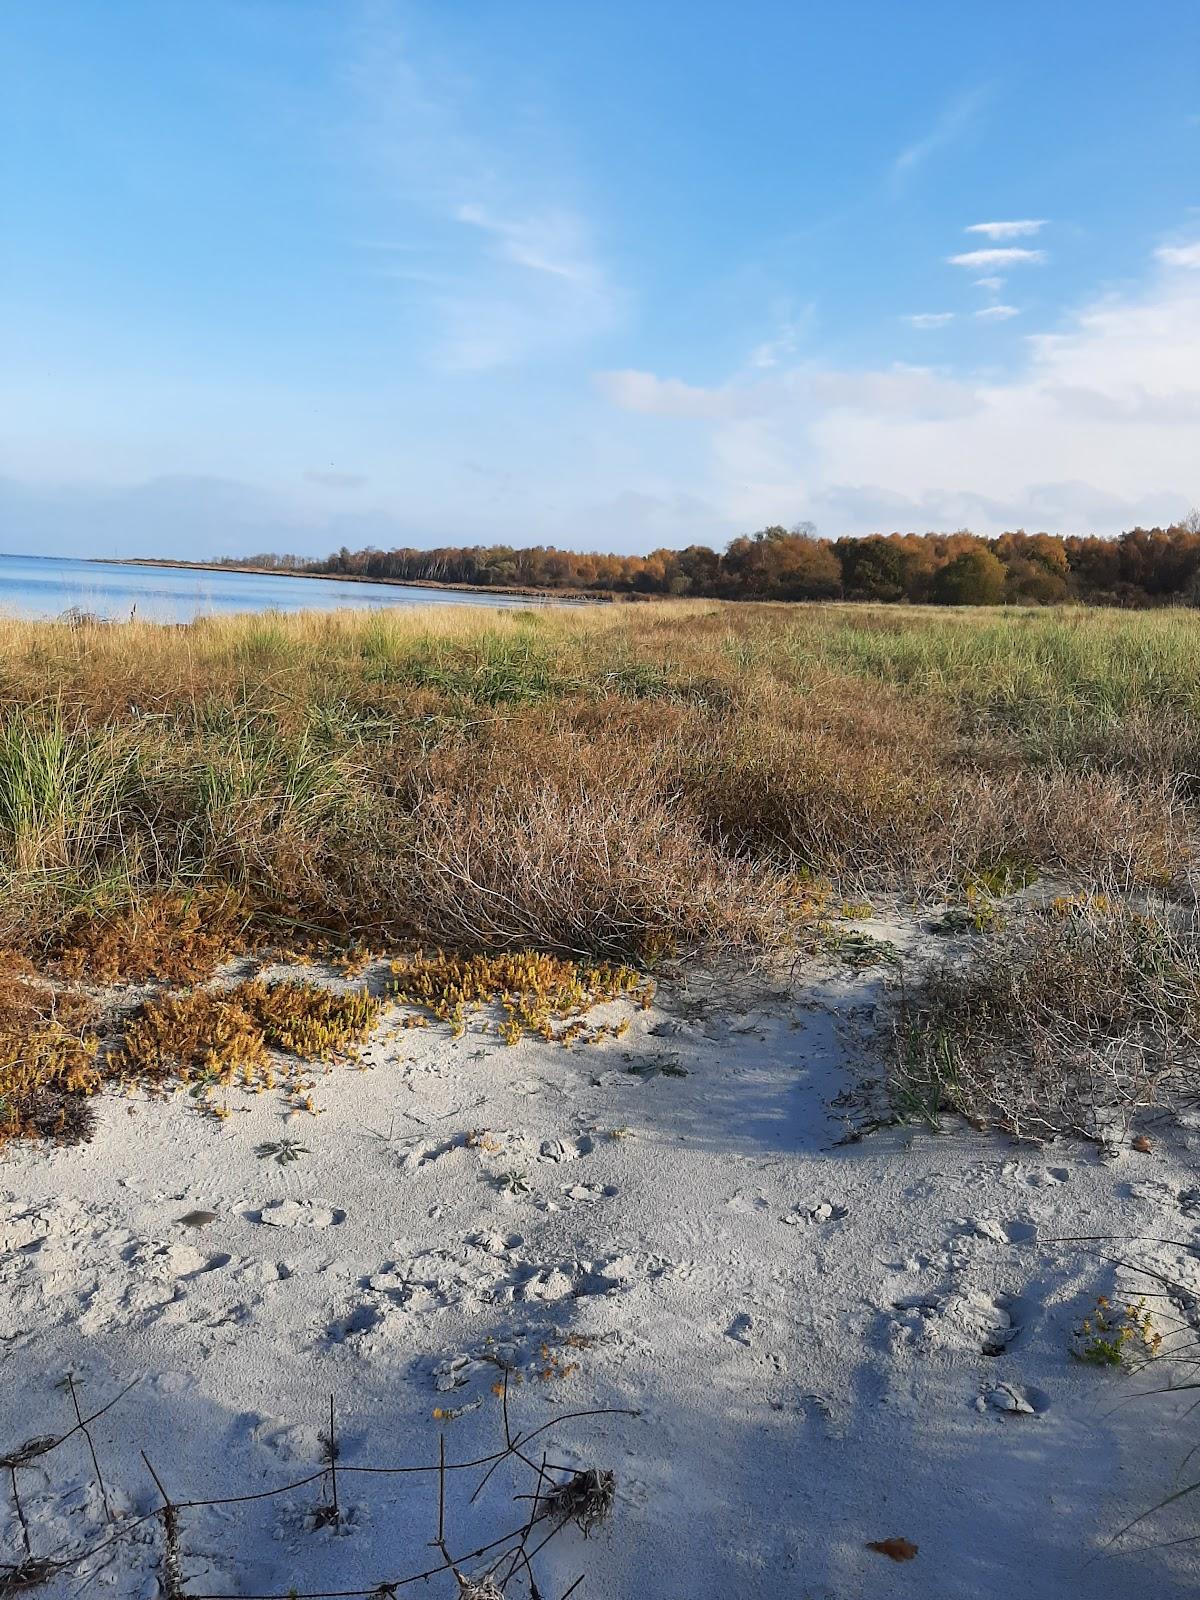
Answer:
[[226, 512, 1200, 606]]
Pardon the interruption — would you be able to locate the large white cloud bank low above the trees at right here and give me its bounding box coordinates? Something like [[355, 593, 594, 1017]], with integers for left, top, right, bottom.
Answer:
[[598, 246, 1200, 534]]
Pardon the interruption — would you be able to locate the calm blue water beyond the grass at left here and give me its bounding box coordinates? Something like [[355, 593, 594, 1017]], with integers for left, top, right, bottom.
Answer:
[[0, 555, 538, 622]]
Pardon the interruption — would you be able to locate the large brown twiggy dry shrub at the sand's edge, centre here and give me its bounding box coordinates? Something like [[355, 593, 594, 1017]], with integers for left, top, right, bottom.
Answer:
[[394, 731, 803, 957]]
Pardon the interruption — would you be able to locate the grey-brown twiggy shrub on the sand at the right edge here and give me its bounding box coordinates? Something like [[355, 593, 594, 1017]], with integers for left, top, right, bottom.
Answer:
[[893, 896, 1200, 1138]]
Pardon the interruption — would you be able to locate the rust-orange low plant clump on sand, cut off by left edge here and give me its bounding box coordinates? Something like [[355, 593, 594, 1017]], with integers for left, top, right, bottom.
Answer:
[[0, 957, 101, 1147]]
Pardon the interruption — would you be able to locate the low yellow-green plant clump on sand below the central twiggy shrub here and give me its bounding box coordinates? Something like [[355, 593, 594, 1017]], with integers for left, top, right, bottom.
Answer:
[[392, 950, 654, 1045]]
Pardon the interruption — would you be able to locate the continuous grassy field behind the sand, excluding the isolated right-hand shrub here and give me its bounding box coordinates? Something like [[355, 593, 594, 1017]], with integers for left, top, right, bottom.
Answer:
[[0, 602, 1200, 976]]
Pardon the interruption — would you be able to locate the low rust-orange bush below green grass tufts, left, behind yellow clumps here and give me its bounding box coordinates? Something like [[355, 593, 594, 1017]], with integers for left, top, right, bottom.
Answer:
[[58, 888, 250, 982]]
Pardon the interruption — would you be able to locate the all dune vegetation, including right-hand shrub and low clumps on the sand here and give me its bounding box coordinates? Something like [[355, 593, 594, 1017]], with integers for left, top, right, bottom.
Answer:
[[0, 600, 1200, 1134]]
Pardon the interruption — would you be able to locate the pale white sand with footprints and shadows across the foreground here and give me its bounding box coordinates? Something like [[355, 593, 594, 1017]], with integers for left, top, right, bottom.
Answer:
[[0, 923, 1200, 1600]]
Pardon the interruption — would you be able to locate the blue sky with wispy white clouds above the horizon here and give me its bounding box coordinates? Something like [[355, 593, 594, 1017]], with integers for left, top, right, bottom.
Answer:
[[0, 0, 1200, 558]]
